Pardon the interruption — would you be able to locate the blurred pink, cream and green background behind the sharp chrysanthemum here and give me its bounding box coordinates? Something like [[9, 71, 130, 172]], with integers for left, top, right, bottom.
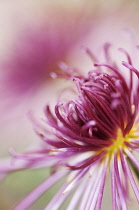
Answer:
[[0, 0, 139, 210]]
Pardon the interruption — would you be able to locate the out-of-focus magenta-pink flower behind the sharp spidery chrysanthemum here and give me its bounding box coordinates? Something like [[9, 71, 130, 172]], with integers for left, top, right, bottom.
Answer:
[[0, 7, 88, 116]]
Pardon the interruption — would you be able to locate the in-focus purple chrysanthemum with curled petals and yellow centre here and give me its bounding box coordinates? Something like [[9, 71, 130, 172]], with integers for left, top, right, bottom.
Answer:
[[0, 44, 139, 210]]
